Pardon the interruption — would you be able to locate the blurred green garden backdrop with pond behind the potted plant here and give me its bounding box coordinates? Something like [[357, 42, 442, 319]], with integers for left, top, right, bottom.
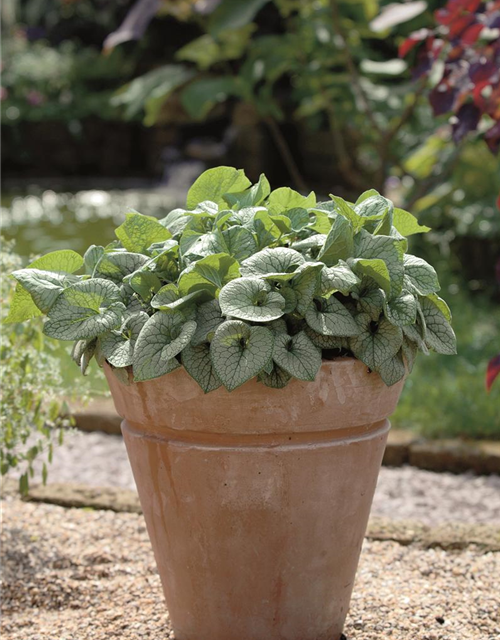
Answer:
[[0, 0, 500, 438]]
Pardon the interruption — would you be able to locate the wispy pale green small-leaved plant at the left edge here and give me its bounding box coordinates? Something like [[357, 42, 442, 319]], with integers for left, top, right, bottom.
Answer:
[[0, 243, 71, 493]]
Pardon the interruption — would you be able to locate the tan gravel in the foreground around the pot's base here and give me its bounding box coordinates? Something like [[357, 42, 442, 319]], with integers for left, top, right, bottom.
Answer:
[[0, 498, 500, 640]]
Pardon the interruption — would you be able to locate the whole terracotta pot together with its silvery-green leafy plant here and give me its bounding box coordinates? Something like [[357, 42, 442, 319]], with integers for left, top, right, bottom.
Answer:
[[6, 167, 455, 640]]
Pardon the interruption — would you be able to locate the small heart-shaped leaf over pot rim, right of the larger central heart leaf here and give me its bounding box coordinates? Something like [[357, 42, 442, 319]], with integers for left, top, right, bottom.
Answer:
[[273, 331, 321, 381]]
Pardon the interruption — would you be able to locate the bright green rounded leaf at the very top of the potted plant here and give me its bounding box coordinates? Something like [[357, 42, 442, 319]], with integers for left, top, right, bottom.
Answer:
[[187, 167, 251, 209]]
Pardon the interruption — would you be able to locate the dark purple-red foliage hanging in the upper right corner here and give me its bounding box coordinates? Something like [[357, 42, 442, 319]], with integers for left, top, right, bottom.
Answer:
[[399, 0, 500, 154]]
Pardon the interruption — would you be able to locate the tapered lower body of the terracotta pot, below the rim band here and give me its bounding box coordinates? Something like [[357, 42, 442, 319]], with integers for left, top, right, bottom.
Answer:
[[122, 420, 389, 640]]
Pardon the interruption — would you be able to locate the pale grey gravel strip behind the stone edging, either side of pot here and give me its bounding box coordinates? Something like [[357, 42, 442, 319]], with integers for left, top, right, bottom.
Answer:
[[25, 432, 500, 525]]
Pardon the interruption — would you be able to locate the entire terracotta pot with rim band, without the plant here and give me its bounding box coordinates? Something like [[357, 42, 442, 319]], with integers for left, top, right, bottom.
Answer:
[[105, 358, 403, 640]]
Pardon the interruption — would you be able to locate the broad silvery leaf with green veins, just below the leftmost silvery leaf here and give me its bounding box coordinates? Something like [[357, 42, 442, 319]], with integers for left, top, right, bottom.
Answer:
[[44, 278, 125, 340]]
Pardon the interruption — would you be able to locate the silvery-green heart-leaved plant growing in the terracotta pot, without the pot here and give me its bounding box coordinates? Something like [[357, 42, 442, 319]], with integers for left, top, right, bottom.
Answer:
[[8, 167, 456, 392]]
